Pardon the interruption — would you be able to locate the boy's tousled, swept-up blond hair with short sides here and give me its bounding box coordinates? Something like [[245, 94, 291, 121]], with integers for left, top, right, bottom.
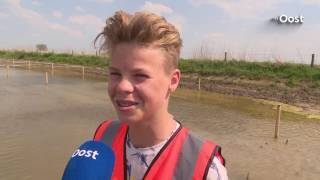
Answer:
[[95, 11, 182, 70]]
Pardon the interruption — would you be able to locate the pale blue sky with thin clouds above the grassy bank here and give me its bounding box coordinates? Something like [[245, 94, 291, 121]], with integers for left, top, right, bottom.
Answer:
[[0, 0, 320, 64]]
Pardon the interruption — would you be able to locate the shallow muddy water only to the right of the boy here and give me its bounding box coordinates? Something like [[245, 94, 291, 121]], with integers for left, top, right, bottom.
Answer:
[[172, 90, 320, 180]]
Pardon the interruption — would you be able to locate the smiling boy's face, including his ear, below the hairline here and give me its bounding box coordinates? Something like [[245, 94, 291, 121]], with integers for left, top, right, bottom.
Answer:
[[108, 43, 180, 123]]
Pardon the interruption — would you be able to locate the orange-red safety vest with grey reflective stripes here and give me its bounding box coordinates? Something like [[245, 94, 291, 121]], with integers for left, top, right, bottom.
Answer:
[[94, 120, 224, 180]]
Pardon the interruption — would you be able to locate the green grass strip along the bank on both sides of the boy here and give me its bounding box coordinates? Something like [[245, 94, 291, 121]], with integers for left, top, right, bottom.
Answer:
[[0, 51, 320, 88]]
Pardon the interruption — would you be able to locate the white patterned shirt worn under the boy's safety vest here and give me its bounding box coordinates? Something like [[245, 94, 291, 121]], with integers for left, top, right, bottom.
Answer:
[[126, 123, 228, 180]]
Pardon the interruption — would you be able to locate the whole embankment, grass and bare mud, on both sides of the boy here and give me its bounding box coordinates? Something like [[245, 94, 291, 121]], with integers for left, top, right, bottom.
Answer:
[[0, 51, 320, 114]]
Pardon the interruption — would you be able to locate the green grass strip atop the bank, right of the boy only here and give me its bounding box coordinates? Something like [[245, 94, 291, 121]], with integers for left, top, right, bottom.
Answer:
[[180, 60, 320, 86]]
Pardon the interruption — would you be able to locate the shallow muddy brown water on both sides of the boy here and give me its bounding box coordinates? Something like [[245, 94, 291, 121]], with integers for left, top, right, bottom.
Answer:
[[0, 68, 320, 180]]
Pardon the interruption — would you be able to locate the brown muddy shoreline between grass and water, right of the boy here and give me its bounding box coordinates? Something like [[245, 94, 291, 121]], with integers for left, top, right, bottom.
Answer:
[[180, 75, 320, 116]]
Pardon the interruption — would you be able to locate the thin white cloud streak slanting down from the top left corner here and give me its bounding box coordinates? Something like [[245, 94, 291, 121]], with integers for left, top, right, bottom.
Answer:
[[5, 0, 82, 37]]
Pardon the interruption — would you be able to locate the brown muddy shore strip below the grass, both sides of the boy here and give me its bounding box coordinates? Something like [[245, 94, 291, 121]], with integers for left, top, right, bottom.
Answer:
[[0, 58, 320, 116]]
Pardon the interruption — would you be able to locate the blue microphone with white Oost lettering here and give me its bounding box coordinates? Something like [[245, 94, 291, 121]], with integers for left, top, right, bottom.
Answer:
[[62, 140, 115, 180]]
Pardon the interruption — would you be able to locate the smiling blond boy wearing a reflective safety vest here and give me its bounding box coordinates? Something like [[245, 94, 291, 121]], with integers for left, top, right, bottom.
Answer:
[[94, 11, 228, 180]]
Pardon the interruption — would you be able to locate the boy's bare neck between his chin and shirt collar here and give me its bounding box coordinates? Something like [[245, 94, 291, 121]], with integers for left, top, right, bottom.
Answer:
[[129, 113, 176, 148]]
